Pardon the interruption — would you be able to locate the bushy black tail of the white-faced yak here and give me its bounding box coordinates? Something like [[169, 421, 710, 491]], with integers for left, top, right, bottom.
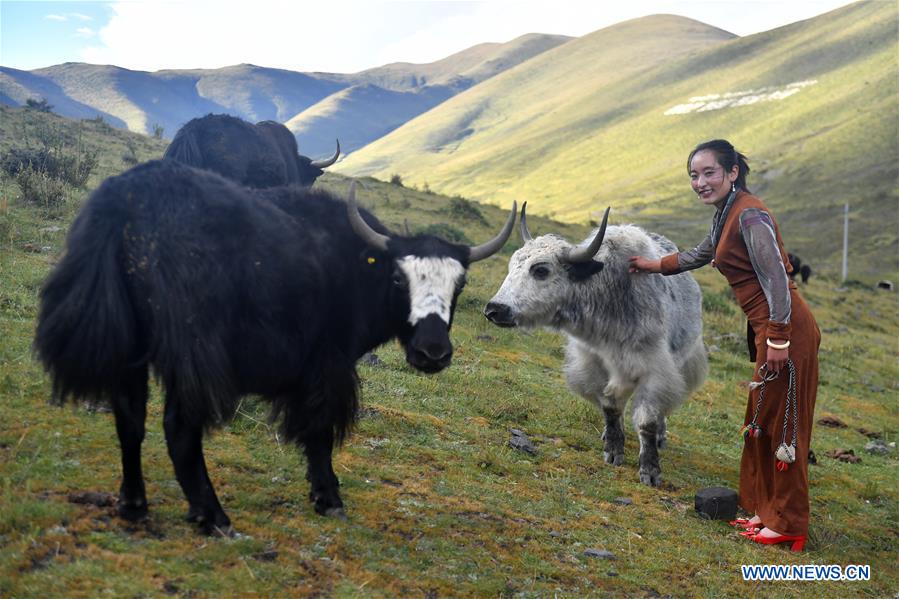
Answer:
[[34, 198, 141, 402]]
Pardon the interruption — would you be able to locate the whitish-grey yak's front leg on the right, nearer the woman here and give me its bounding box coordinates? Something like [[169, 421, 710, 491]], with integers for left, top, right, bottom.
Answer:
[[634, 357, 685, 487]]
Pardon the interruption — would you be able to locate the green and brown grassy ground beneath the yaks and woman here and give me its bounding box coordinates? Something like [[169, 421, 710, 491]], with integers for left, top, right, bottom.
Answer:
[[0, 109, 899, 598]]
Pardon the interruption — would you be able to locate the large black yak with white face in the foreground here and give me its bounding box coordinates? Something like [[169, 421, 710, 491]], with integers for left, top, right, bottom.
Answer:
[[34, 160, 515, 532]]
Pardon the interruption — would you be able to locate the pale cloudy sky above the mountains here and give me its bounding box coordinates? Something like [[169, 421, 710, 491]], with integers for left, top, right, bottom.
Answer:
[[0, 0, 856, 73]]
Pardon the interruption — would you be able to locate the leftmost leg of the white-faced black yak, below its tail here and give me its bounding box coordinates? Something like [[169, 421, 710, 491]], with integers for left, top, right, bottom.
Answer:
[[112, 367, 147, 522]]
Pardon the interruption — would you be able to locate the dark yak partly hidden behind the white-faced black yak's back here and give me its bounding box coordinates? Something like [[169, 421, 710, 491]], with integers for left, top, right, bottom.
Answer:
[[163, 114, 340, 188]]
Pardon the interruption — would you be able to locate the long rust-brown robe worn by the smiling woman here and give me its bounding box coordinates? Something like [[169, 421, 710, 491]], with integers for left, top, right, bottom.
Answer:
[[662, 190, 821, 535]]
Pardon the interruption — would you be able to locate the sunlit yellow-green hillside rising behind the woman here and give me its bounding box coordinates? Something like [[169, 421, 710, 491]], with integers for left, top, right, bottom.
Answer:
[[338, 2, 899, 278]]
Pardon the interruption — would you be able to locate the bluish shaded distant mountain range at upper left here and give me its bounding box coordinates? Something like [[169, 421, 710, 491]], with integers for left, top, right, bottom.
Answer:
[[0, 34, 570, 156]]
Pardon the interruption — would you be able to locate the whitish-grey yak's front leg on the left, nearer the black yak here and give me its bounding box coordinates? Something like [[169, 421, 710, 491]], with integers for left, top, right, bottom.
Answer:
[[564, 339, 629, 466]]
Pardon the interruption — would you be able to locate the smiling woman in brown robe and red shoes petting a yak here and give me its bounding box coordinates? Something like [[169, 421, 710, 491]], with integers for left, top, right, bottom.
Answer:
[[630, 139, 821, 551]]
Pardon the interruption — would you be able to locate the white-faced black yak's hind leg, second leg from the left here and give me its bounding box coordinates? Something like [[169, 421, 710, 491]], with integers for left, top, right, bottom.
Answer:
[[164, 398, 232, 535]]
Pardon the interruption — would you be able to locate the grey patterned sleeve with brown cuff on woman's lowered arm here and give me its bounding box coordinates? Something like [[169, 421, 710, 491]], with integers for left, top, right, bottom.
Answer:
[[740, 208, 791, 339]]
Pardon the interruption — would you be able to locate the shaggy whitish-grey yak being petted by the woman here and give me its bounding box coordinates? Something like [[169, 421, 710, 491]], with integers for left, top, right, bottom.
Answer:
[[484, 206, 708, 486]]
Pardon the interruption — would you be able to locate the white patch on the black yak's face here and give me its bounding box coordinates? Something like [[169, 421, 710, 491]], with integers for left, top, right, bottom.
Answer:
[[397, 256, 465, 326]]
